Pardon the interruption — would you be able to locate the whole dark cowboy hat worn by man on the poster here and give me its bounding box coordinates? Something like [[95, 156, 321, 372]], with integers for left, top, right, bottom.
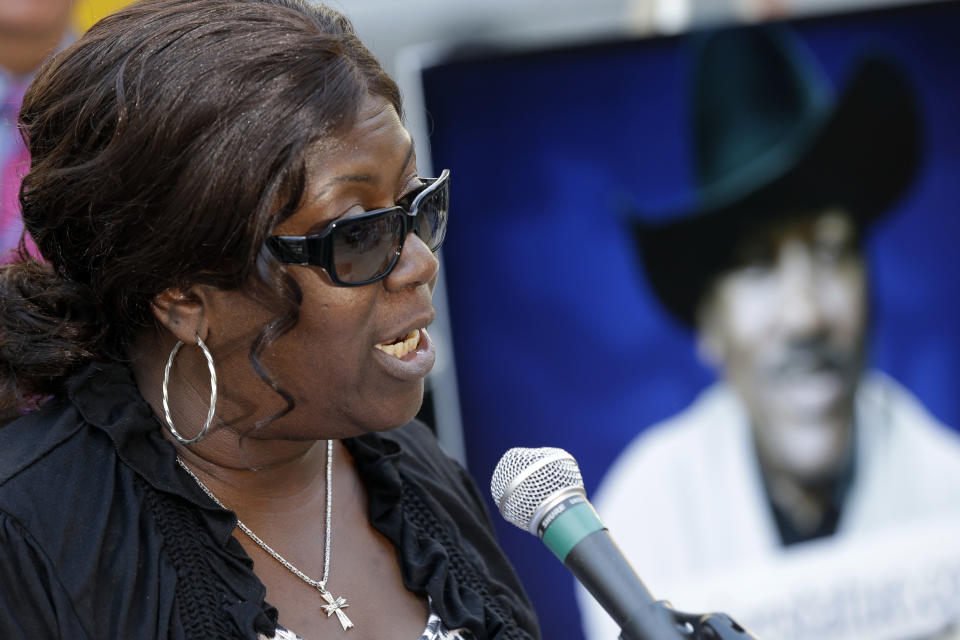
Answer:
[[632, 26, 921, 326]]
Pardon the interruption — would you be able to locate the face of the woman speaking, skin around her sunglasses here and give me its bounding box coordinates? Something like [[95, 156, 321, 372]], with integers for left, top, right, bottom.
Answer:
[[204, 98, 439, 440]]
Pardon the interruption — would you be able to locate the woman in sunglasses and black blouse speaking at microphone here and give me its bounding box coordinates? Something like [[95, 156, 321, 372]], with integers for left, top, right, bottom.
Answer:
[[0, 0, 538, 640]]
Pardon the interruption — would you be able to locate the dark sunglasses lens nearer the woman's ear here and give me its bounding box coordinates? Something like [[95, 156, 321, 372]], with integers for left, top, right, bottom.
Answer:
[[333, 210, 403, 283]]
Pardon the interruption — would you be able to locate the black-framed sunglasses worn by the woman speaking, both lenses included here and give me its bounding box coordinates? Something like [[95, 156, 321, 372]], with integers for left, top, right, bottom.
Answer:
[[267, 169, 450, 287]]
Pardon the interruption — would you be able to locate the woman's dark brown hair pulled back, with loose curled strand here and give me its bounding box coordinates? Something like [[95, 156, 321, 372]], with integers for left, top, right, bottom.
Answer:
[[0, 0, 402, 410]]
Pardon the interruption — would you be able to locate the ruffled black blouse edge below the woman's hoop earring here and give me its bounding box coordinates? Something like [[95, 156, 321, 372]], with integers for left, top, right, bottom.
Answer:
[[68, 363, 278, 640]]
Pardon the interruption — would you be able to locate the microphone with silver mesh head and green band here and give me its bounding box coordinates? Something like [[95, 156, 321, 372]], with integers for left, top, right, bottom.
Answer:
[[490, 447, 684, 640]]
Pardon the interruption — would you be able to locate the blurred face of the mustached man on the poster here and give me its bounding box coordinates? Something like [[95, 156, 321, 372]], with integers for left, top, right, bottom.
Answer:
[[699, 209, 868, 480]]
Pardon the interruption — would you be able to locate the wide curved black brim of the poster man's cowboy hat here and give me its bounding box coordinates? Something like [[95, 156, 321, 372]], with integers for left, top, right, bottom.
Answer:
[[632, 57, 922, 326]]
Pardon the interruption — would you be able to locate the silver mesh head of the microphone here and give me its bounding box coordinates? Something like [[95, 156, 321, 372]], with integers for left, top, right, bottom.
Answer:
[[490, 447, 584, 535]]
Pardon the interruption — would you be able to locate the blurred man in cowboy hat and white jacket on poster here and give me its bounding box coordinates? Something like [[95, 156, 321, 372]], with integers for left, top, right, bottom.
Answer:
[[579, 27, 960, 640]]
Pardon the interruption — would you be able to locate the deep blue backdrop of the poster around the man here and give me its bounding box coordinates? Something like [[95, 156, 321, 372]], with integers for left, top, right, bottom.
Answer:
[[423, 3, 960, 640]]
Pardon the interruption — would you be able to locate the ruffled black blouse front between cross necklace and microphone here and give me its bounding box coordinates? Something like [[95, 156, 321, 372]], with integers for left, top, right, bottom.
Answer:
[[344, 424, 539, 640]]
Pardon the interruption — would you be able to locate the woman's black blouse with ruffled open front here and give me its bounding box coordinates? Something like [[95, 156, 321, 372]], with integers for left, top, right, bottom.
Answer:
[[0, 363, 539, 640]]
